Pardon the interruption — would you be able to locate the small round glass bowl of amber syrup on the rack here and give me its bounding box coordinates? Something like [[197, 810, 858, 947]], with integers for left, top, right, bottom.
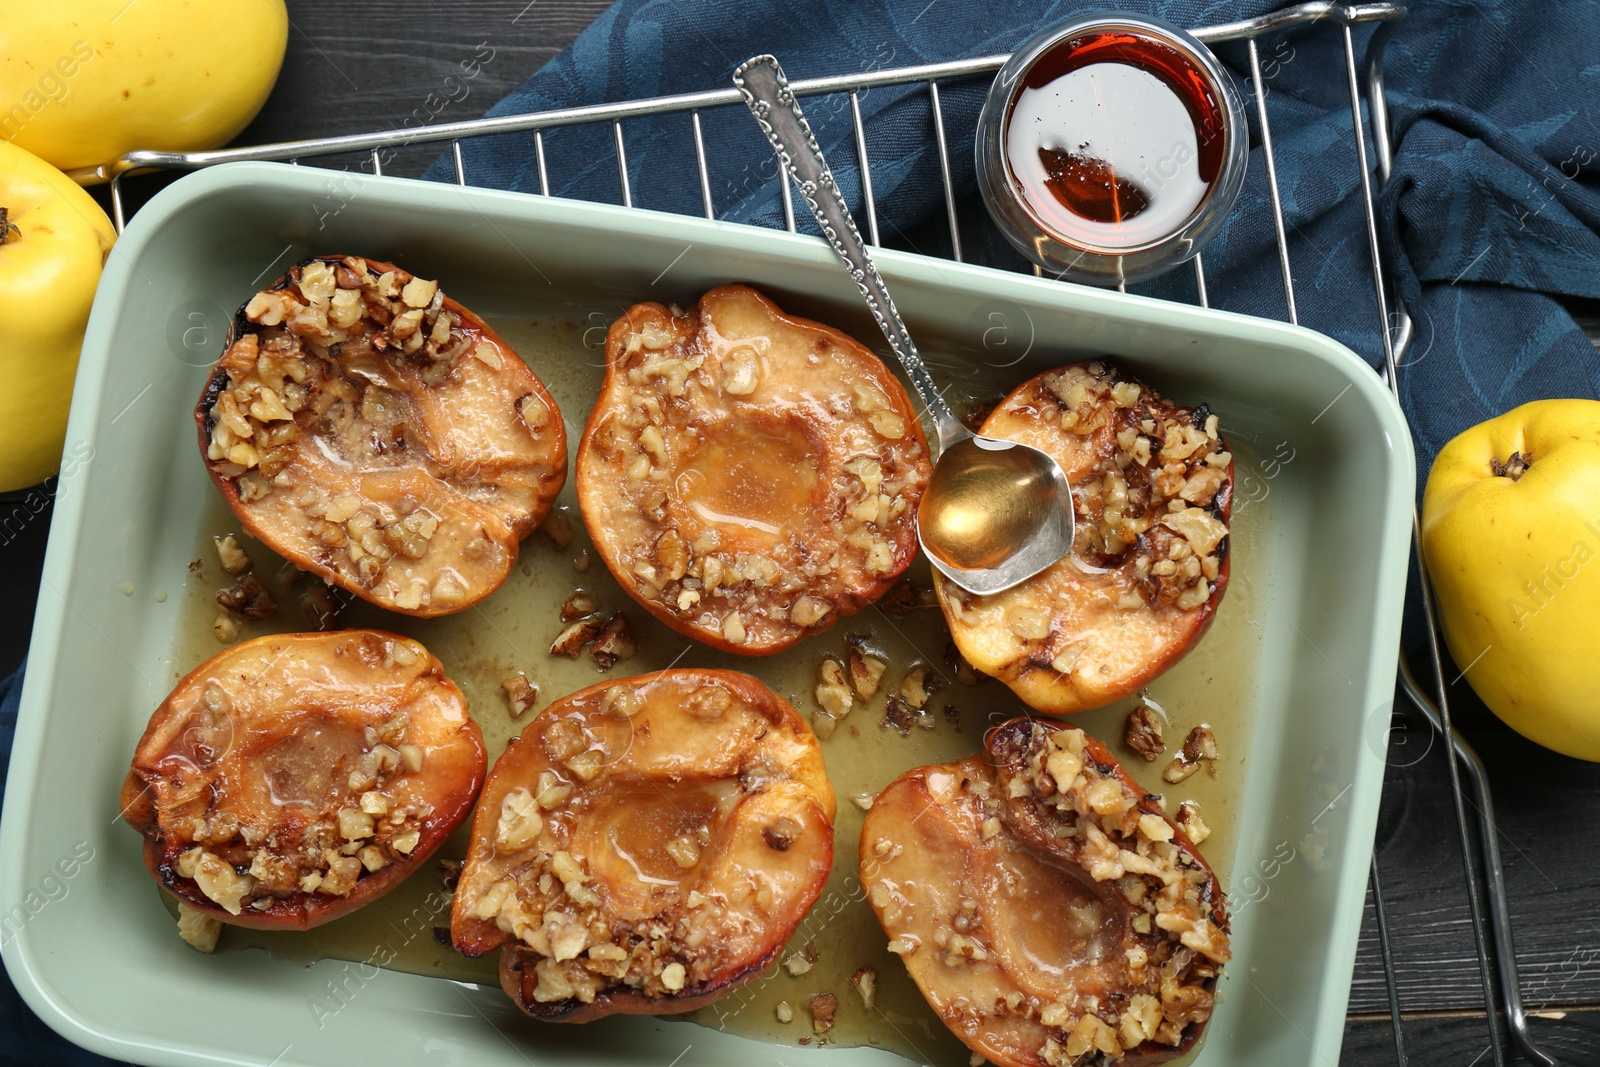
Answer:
[[976, 11, 1250, 285]]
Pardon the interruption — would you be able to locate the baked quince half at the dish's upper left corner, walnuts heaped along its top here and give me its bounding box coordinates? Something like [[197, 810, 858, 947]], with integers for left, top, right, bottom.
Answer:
[[195, 256, 566, 616]]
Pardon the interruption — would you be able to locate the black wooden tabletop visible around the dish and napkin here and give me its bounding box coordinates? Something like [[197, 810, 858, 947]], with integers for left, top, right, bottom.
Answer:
[[0, 0, 1600, 1067]]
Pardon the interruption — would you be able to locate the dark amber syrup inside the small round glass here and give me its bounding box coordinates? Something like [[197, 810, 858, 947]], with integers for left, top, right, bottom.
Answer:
[[1003, 30, 1224, 248]]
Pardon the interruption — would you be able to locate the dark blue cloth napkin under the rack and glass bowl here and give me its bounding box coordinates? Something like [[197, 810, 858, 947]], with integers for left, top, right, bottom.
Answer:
[[427, 0, 1600, 476]]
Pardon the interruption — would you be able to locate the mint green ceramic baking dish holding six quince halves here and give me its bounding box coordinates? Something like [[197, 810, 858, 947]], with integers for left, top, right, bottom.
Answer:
[[0, 163, 1413, 1067]]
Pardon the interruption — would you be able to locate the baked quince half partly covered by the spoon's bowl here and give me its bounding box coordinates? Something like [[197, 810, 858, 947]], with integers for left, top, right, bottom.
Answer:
[[933, 362, 1234, 715]]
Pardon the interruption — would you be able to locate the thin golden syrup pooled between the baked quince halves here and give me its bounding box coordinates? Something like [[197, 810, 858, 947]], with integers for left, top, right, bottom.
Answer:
[[165, 293, 1260, 1067]]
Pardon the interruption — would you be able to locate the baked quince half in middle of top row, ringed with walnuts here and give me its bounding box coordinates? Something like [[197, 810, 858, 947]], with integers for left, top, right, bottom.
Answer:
[[578, 285, 931, 656]]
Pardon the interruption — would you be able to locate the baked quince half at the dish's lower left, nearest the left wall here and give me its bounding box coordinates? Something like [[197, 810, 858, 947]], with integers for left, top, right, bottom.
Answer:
[[122, 630, 485, 929]]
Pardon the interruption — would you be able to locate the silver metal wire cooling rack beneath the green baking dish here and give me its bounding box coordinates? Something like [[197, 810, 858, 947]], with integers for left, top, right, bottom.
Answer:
[[77, 2, 1555, 1067]]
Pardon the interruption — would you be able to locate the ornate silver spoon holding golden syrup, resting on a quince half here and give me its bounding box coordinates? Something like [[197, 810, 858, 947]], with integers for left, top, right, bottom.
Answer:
[[733, 56, 1072, 593]]
